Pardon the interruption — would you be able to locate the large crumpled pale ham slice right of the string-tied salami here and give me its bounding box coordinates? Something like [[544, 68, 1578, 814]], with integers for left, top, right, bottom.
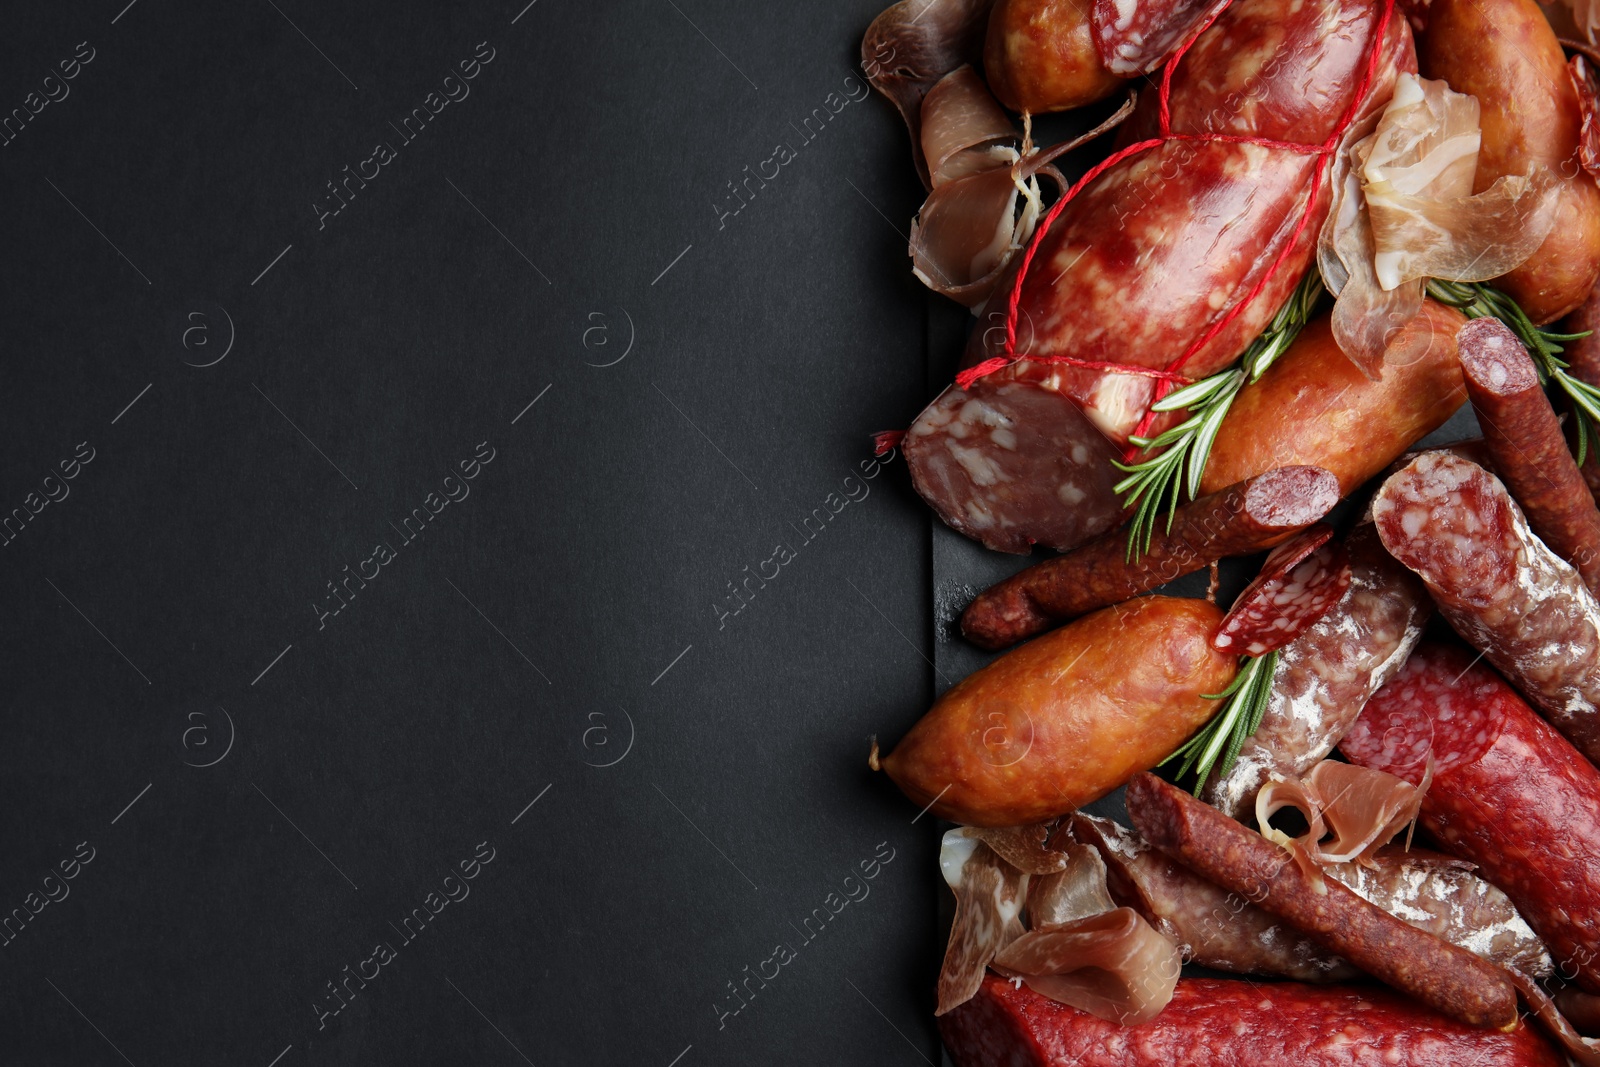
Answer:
[[1318, 74, 1555, 378]]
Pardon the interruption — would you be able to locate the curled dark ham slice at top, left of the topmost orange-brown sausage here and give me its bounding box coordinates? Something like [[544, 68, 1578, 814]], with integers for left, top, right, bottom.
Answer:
[[861, 0, 992, 189]]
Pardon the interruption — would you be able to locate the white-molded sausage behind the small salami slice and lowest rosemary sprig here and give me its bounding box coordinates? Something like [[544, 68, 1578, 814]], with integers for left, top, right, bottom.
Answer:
[[1200, 523, 1432, 819]]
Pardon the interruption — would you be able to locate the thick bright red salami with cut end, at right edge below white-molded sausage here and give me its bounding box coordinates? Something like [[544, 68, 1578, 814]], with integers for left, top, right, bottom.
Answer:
[[1339, 643, 1600, 993]]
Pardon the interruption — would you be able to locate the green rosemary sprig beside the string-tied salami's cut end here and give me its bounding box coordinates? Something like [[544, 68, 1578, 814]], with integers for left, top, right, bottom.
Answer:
[[1112, 270, 1324, 560]]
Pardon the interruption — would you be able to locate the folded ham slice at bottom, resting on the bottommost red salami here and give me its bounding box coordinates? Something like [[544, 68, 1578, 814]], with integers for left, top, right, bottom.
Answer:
[[995, 907, 1182, 1025]]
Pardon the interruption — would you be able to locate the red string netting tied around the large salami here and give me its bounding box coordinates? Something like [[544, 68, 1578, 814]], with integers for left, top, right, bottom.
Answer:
[[955, 0, 1394, 459]]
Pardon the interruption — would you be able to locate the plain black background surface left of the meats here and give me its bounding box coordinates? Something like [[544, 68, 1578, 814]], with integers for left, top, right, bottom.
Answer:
[[0, 0, 958, 1067]]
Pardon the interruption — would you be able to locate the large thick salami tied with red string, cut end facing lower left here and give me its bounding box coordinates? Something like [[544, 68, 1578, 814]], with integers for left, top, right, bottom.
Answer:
[[906, 0, 1414, 552]]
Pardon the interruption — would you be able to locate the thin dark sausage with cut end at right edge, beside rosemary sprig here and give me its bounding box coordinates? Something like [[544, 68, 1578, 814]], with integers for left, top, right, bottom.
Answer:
[[1456, 318, 1600, 592]]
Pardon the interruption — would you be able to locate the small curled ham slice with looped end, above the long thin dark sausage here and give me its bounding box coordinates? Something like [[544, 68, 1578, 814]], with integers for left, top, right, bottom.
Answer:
[[1256, 760, 1432, 873]]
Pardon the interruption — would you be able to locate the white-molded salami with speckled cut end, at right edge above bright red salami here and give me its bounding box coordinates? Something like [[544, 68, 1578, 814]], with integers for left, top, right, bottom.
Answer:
[[1373, 451, 1600, 760]]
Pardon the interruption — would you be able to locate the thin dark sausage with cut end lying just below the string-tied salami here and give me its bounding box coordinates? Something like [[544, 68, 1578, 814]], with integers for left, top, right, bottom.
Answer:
[[962, 467, 1339, 649]]
